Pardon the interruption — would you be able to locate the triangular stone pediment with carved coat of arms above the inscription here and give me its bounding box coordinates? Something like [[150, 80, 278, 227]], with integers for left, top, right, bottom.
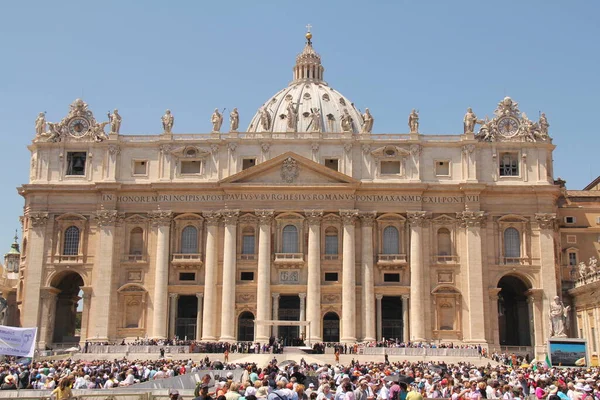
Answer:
[[220, 151, 360, 186]]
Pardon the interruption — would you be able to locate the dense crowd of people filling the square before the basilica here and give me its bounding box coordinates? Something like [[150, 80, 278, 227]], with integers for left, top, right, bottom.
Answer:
[[0, 355, 600, 400]]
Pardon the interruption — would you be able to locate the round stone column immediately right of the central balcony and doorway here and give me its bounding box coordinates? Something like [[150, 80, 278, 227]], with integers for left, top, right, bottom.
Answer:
[[304, 210, 323, 343]]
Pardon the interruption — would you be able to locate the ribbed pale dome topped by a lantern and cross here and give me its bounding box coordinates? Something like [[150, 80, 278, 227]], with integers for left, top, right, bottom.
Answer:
[[248, 32, 363, 133]]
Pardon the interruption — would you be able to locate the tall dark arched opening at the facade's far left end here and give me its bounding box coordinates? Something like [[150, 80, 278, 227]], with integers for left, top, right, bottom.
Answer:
[[52, 272, 83, 343]]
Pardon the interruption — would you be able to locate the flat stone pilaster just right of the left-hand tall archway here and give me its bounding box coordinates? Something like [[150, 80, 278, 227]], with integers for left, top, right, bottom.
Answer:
[[88, 210, 120, 341]]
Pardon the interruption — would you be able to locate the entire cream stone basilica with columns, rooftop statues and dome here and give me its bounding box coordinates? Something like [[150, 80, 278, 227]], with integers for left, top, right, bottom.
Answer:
[[19, 31, 561, 354]]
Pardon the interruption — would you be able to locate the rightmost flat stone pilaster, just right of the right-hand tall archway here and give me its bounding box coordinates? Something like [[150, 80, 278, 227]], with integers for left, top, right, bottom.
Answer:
[[535, 213, 560, 345]]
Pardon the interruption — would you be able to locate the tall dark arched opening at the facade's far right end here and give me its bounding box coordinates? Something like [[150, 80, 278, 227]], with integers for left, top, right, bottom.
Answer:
[[498, 275, 531, 346]]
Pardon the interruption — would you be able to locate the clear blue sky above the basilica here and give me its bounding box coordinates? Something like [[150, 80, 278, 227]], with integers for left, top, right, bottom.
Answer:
[[0, 0, 600, 248]]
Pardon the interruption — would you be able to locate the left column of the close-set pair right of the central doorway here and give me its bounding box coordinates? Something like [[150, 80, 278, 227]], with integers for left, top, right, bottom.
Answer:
[[340, 210, 358, 343]]
